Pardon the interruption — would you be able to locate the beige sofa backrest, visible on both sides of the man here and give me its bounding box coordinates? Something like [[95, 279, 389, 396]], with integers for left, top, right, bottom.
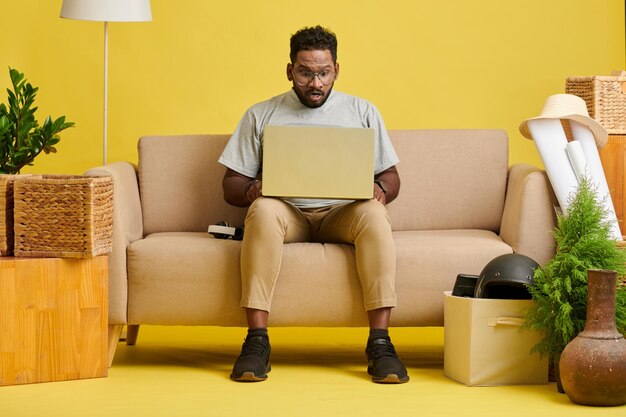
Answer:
[[138, 130, 508, 235]]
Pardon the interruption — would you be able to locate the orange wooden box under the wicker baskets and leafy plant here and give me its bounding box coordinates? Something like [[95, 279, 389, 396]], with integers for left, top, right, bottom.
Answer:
[[0, 256, 108, 386]]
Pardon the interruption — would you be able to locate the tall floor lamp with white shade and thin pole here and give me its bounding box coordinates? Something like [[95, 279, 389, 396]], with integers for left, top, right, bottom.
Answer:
[[61, 0, 152, 165]]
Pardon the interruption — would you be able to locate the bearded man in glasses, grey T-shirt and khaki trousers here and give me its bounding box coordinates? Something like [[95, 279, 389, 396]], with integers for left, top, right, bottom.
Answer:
[[219, 26, 409, 383]]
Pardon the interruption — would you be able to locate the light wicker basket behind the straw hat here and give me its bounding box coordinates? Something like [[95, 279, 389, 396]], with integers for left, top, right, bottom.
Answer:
[[565, 75, 626, 135]]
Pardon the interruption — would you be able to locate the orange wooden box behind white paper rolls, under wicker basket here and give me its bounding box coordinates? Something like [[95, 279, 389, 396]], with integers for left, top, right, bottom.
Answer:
[[600, 135, 626, 235]]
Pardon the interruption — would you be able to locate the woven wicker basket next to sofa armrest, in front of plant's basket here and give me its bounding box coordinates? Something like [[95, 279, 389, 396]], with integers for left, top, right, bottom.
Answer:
[[14, 175, 113, 258]]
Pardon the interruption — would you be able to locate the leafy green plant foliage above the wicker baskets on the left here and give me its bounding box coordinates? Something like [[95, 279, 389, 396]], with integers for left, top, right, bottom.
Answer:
[[0, 68, 74, 174]]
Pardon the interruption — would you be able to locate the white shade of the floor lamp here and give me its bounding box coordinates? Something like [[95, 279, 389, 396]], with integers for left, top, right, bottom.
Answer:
[[61, 0, 152, 22]]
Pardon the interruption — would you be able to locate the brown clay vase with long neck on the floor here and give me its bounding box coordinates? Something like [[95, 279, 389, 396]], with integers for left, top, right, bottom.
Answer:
[[559, 270, 626, 406]]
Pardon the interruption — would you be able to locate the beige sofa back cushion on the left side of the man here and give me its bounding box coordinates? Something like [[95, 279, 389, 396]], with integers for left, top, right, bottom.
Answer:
[[138, 135, 245, 235]]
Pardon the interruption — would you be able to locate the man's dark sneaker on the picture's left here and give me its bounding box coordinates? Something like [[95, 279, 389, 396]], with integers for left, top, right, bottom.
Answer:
[[230, 334, 272, 382]]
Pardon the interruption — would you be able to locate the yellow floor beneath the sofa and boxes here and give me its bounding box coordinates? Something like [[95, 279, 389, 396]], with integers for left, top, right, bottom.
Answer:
[[0, 326, 626, 417]]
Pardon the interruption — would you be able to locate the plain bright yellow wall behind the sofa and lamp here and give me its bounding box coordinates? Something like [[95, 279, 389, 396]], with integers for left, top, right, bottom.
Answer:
[[0, 0, 626, 173]]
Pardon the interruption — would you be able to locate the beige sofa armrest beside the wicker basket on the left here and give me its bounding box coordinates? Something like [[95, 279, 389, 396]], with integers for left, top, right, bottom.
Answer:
[[85, 162, 143, 325]]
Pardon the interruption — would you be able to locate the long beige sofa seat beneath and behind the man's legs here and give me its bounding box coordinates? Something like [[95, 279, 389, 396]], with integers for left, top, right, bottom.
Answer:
[[128, 230, 511, 326]]
